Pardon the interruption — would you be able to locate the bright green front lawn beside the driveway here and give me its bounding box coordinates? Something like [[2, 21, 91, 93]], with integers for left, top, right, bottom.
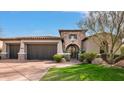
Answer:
[[41, 64, 124, 81]]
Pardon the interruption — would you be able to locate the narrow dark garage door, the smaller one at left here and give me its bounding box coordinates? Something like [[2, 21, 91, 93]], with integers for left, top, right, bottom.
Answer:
[[9, 44, 20, 59]]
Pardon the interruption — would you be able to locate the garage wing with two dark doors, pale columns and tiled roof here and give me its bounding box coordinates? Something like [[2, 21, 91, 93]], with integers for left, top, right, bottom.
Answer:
[[1, 36, 63, 60]]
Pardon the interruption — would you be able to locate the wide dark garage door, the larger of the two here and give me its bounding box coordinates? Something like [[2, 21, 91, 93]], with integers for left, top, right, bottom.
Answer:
[[27, 44, 57, 60]]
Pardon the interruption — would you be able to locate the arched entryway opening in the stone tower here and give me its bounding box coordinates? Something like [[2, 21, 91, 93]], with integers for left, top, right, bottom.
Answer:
[[66, 44, 79, 58]]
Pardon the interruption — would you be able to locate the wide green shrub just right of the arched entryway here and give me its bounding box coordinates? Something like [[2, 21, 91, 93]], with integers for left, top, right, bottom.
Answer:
[[80, 53, 97, 63]]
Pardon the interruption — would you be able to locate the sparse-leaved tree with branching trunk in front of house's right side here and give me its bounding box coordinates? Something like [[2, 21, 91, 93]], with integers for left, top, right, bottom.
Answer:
[[78, 11, 124, 63]]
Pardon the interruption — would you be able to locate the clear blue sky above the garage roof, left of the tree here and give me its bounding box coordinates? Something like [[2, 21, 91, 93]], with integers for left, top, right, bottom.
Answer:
[[0, 11, 86, 37]]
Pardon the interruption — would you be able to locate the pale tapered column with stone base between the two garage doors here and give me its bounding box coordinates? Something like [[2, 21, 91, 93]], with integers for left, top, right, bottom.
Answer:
[[18, 41, 27, 60]]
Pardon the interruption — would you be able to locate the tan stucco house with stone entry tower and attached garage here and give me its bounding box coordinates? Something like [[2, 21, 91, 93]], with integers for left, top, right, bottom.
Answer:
[[0, 29, 122, 60]]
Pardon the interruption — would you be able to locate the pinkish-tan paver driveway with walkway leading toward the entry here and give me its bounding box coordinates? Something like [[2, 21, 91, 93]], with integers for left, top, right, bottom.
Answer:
[[0, 60, 79, 81]]
